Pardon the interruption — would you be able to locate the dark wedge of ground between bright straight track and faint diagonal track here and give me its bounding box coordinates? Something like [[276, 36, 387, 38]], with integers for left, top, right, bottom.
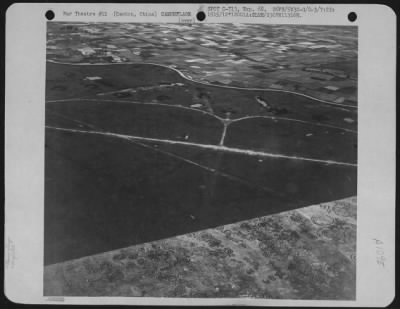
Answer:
[[147, 143, 357, 202]]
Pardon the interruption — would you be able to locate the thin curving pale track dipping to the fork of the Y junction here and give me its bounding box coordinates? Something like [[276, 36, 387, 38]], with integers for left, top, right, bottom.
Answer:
[[47, 98, 357, 133]]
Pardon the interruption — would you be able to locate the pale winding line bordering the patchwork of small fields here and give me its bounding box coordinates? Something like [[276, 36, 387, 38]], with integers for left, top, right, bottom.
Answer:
[[47, 59, 357, 109]]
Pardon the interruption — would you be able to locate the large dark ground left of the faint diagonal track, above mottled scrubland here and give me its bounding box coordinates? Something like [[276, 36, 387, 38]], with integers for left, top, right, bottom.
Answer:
[[45, 130, 279, 264]]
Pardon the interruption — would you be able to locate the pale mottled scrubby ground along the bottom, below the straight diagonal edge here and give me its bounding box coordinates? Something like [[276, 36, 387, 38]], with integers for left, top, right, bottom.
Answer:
[[44, 197, 357, 300]]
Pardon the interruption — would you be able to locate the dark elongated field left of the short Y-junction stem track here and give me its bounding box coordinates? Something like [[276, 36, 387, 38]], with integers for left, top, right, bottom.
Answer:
[[46, 100, 222, 144]]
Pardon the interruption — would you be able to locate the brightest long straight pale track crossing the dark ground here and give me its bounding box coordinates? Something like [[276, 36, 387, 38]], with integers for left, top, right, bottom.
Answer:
[[46, 126, 357, 167]]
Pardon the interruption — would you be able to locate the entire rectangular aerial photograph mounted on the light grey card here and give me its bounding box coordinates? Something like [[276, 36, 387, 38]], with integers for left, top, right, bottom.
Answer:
[[44, 22, 358, 300]]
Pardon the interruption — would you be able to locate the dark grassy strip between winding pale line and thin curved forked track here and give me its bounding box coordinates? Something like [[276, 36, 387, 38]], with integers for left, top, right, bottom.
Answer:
[[46, 63, 357, 131]]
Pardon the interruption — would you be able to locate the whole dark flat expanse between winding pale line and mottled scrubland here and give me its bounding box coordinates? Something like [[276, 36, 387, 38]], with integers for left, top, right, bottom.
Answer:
[[45, 63, 357, 265]]
